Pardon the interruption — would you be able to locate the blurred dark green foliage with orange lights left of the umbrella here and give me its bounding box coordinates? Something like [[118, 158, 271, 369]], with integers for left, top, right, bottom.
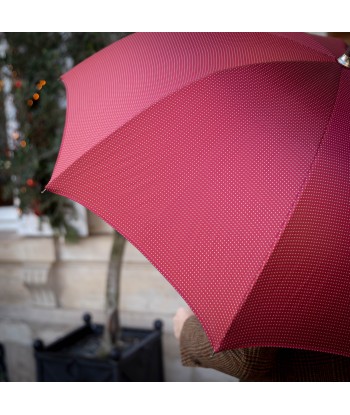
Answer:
[[0, 32, 128, 241]]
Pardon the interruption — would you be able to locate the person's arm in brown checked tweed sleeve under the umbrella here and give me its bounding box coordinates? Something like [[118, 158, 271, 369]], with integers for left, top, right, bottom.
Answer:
[[179, 315, 277, 381]]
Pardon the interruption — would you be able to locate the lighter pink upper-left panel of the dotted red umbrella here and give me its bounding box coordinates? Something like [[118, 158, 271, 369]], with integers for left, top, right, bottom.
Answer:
[[52, 33, 334, 178]]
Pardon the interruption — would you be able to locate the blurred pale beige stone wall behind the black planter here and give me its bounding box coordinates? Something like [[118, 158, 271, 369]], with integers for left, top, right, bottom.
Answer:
[[0, 213, 235, 381]]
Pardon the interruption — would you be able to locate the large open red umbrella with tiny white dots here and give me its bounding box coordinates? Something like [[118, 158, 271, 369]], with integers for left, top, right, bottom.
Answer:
[[46, 33, 350, 356]]
